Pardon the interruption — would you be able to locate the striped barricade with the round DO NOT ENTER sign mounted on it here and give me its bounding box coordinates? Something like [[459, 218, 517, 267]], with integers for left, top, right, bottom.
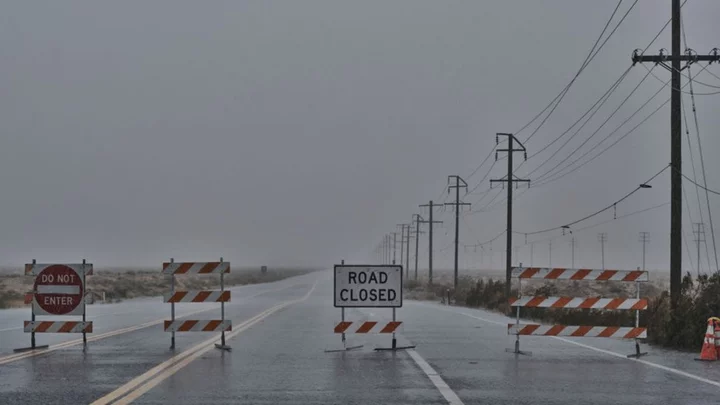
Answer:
[[15, 260, 93, 352]]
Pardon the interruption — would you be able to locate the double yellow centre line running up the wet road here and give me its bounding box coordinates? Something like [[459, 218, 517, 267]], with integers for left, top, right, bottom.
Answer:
[[91, 281, 317, 405]]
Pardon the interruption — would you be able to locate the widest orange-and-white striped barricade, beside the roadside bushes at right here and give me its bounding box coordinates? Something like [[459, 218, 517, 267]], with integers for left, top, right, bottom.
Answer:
[[506, 267, 649, 358]]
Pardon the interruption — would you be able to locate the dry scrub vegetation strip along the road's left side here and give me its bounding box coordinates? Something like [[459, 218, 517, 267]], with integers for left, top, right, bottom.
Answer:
[[0, 268, 316, 308]]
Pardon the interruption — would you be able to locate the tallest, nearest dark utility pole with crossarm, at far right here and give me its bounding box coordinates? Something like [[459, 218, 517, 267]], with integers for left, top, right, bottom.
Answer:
[[632, 0, 720, 309]]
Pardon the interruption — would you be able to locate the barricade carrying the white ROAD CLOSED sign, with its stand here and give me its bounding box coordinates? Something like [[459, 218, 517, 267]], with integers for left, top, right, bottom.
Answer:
[[325, 260, 415, 352]]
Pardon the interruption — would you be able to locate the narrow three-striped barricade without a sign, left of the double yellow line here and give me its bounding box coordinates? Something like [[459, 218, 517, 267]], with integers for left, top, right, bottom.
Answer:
[[162, 257, 232, 351]]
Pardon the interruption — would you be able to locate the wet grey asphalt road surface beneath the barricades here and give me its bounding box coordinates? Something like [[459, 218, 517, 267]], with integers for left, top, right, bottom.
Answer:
[[0, 266, 720, 405]]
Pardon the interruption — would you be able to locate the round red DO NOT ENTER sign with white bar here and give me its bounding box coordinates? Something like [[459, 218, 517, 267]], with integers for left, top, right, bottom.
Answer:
[[33, 264, 84, 315]]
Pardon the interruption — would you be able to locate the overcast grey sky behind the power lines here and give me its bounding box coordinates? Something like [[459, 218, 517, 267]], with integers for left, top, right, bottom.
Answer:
[[0, 0, 720, 269]]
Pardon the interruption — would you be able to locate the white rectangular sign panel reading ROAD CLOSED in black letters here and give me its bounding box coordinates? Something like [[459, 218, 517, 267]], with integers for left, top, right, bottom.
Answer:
[[335, 265, 403, 308]]
